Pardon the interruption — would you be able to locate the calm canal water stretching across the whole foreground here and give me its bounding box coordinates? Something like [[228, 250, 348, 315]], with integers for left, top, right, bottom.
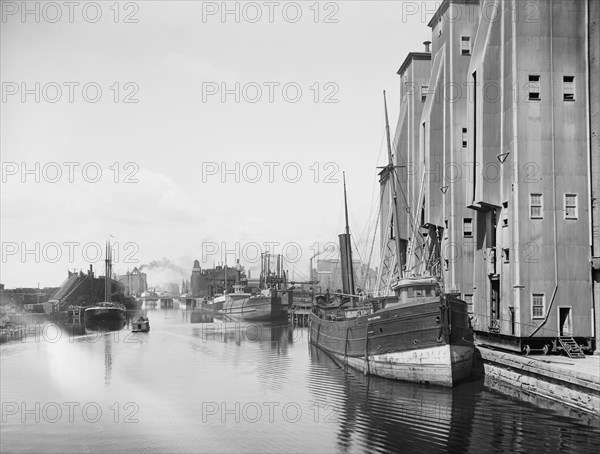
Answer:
[[0, 309, 600, 454]]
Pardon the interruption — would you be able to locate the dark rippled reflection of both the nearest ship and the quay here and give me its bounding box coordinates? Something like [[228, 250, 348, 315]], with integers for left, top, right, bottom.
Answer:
[[308, 346, 600, 453]]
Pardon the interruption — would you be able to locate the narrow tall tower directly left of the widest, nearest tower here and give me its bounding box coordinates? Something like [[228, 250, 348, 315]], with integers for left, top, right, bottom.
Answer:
[[419, 0, 479, 302]]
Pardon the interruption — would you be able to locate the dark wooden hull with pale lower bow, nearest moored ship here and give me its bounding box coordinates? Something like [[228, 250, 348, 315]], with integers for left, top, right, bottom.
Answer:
[[309, 301, 474, 387]]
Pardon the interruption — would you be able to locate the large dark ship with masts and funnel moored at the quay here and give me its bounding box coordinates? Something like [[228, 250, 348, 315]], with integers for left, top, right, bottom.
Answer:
[[309, 92, 474, 387]]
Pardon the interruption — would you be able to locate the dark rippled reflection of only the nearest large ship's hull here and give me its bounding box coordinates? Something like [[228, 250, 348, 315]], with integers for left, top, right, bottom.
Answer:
[[308, 346, 478, 452]]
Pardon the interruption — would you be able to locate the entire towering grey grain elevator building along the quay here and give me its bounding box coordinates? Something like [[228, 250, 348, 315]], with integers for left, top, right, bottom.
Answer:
[[392, 0, 600, 351]]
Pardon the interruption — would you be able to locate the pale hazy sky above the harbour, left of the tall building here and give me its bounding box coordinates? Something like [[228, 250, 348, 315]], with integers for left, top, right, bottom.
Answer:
[[0, 0, 440, 288]]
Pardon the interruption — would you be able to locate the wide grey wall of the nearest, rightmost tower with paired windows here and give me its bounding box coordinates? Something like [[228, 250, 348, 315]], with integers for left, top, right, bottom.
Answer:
[[469, 0, 592, 337]]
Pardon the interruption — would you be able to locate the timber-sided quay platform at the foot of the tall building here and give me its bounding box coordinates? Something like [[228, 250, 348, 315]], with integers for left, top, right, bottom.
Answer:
[[477, 346, 600, 415]]
